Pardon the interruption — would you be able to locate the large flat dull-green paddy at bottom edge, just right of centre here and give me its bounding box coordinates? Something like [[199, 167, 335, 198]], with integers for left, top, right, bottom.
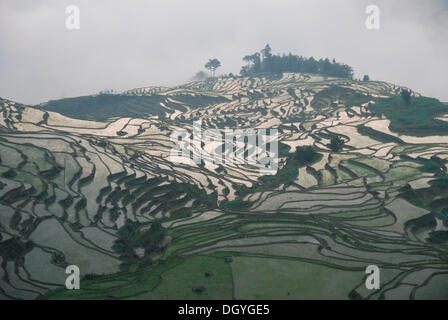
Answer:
[[232, 257, 364, 299]]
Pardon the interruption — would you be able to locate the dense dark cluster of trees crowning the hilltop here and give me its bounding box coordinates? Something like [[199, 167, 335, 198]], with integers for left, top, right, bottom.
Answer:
[[240, 44, 353, 79]]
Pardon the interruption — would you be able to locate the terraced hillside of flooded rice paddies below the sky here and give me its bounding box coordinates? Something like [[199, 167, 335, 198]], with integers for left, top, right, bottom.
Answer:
[[0, 74, 448, 299]]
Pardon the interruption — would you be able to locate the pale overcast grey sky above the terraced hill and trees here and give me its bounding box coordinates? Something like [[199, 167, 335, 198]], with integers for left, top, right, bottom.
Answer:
[[0, 0, 448, 104]]
